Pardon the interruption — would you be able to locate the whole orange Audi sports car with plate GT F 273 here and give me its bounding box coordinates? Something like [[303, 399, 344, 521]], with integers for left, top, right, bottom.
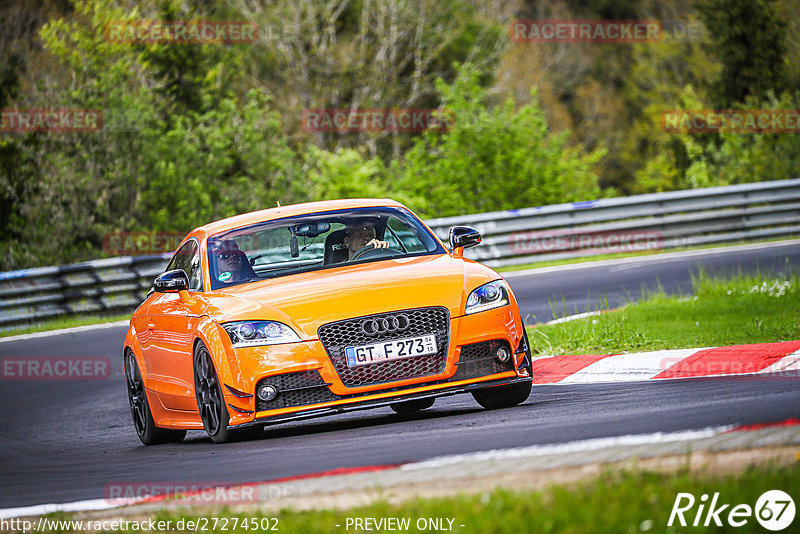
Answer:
[[123, 199, 532, 445]]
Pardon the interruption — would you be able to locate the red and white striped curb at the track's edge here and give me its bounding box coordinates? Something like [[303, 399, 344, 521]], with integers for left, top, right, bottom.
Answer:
[[533, 341, 800, 384]]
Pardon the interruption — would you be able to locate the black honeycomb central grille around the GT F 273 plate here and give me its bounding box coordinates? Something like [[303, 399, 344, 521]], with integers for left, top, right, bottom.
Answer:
[[319, 307, 450, 387]]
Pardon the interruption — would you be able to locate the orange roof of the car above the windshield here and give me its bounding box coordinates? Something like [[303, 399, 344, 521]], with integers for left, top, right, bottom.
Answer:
[[193, 198, 405, 237]]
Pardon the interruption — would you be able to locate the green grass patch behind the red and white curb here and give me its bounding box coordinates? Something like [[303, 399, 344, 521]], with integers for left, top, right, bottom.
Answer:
[[528, 273, 800, 354]]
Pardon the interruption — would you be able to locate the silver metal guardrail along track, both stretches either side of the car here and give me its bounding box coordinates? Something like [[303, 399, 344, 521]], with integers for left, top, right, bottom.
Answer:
[[0, 179, 800, 329]]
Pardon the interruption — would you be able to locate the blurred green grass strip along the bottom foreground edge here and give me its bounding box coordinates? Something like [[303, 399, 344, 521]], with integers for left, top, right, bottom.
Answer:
[[40, 462, 800, 534]]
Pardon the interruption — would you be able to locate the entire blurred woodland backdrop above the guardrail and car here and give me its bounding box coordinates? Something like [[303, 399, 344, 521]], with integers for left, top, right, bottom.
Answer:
[[0, 0, 800, 270]]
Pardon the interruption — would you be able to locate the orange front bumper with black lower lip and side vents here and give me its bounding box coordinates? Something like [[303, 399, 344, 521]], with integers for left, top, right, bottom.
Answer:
[[224, 306, 531, 427]]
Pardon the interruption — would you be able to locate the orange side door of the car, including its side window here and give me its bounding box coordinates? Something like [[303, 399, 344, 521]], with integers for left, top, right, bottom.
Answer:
[[143, 239, 203, 411]]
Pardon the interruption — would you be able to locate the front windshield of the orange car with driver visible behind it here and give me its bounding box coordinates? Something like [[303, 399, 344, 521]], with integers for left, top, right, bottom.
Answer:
[[208, 208, 445, 289]]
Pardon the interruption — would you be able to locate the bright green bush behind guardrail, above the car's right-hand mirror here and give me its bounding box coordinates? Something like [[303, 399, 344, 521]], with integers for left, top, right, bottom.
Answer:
[[395, 65, 603, 217]]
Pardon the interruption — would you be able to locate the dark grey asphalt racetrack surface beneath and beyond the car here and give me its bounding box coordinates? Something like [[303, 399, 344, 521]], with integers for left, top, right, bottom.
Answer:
[[0, 242, 800, 508]]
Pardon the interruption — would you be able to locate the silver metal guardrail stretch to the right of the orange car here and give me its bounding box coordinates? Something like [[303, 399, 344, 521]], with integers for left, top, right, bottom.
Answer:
[[426, 179, 800, 267]]
